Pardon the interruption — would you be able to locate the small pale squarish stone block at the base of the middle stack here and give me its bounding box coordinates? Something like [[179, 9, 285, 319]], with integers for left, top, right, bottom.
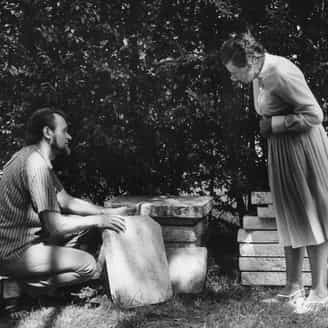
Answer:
[[166, 247, 207, 294]]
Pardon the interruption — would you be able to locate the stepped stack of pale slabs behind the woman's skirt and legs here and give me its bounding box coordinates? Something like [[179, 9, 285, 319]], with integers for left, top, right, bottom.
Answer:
[[238, 192, 311, 286]]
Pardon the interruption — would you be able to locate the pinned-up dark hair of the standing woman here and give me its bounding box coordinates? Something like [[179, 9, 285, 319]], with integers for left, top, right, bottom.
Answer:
[[220, 32, 264, 67]]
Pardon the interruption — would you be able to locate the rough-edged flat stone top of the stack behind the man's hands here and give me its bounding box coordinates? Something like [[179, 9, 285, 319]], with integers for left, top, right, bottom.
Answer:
[[104, 196, 213, 219]]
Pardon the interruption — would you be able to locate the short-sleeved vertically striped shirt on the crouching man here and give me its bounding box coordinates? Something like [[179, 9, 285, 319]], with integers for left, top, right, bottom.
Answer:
[[0, 146, 63, 261]]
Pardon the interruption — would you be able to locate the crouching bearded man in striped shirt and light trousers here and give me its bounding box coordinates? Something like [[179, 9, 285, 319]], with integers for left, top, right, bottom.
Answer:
[[0, 108, 128, 302]]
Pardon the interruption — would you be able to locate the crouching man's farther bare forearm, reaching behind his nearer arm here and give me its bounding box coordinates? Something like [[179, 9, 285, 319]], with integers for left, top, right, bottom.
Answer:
[[57, 189, 131, 216]]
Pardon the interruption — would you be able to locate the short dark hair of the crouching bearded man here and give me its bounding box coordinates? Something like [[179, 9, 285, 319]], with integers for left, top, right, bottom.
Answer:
[[25, 107, 66, 145]]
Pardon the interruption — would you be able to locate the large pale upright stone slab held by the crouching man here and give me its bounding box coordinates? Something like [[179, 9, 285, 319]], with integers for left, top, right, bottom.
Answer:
[[103, 216, 172, 308]]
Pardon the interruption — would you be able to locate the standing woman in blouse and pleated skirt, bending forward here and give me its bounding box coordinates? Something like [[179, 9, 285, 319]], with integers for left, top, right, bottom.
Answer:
[[220, 33, 328, 313]]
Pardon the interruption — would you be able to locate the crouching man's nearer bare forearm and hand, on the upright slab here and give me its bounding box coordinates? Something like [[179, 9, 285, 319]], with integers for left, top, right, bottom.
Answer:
[[39, 211, 125, 237]]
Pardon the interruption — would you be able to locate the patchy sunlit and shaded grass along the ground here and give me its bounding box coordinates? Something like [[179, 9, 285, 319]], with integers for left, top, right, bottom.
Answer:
[[0, 265, 328, 328]]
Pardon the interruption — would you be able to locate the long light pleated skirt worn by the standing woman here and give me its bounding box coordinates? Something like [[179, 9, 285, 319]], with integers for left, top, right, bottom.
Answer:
[[268, 125, 328, 248]]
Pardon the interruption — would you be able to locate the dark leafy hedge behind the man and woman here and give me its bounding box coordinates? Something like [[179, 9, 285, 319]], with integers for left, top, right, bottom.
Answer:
[[0, 0, 328, 219]]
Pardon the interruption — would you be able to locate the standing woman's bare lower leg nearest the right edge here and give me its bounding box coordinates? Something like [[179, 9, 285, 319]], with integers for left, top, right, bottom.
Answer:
[[307, 242, 328, 301]]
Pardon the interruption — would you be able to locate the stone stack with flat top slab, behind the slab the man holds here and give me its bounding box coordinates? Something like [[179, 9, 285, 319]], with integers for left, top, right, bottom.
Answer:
[[104, 196, 213, 293]]
